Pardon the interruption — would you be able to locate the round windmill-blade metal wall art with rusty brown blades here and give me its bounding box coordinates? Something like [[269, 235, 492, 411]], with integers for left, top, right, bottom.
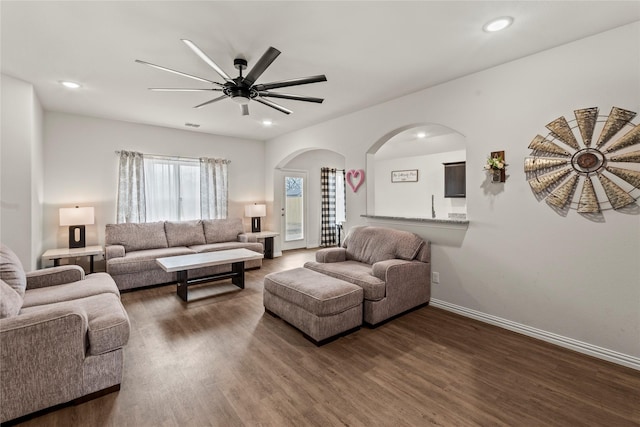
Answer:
[[524, 107, 640, 215]]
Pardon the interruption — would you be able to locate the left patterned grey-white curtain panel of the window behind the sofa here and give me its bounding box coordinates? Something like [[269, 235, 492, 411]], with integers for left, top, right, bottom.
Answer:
[[116, 151, 146, 223]]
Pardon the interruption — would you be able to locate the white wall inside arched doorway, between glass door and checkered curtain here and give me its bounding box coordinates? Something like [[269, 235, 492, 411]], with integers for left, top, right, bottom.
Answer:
[[282, 150, 344, 248]]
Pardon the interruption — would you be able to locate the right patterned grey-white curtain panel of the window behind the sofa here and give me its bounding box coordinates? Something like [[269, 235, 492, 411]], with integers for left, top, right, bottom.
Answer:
[[200, 157, 231, 219]]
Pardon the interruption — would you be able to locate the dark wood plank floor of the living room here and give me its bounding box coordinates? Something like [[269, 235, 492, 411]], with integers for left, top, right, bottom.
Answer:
[[13, 251, 640, 427]]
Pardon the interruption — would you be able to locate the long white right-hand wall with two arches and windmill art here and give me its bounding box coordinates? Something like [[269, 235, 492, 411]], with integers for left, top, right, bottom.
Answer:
[[265, 23, 640, 368]]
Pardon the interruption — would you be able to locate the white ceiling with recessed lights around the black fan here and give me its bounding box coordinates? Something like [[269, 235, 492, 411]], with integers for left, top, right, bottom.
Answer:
[[0, 0, 640, 140]]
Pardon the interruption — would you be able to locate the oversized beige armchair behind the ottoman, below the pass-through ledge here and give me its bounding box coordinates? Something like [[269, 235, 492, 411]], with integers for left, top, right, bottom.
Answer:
[[304, 226, 431, 325]]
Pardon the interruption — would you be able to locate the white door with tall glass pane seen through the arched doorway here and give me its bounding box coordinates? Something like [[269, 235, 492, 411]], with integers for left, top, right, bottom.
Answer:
[[281, 171, 307, 250]]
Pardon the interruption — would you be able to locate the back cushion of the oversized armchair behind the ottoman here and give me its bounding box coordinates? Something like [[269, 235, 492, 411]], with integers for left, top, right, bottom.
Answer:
[[343, 226, 425, 264]]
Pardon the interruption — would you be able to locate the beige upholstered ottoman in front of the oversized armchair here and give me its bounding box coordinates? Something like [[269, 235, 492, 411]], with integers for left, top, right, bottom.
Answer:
[[264, 268, 363, 345]]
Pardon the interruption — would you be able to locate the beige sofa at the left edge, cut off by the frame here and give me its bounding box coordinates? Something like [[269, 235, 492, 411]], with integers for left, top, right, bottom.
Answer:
[[0, 245, 130, 423]]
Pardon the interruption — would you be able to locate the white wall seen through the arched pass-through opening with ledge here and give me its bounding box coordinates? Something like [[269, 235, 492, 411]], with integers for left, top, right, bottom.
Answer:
[[376, 150, 467, 219]]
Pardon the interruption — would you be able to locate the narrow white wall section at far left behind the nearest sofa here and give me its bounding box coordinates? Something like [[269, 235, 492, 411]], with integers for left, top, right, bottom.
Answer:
[[0, 74, 43, 271]]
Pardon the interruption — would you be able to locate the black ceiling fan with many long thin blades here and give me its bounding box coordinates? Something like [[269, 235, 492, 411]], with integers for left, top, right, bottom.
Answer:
[[136, 39, 327, 116]]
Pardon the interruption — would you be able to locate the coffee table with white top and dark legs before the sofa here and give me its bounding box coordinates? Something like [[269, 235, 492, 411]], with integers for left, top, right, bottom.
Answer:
[[156, 249, 264, 301]]
